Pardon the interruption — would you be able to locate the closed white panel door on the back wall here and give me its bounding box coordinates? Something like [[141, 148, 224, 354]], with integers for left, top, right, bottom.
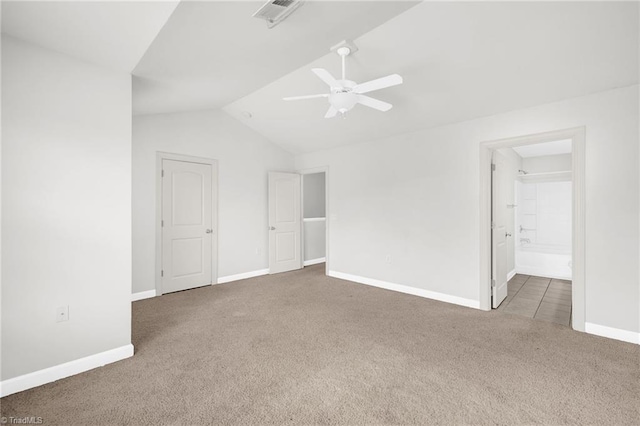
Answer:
[[162, 159, 214, 293]]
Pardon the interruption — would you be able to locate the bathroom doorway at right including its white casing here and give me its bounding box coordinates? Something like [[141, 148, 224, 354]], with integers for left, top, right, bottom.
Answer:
[[480, 128, 585, 331]]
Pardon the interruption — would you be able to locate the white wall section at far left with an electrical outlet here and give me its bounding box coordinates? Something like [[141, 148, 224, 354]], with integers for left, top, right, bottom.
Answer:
[[2, 36, 131, 380]]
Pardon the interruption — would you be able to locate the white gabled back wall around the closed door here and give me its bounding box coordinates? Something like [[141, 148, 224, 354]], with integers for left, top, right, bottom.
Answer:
[[133, 110, 293, 293]]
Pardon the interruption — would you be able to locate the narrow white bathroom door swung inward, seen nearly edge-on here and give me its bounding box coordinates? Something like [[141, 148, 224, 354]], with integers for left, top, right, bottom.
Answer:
[[491, 151, 508, 308]]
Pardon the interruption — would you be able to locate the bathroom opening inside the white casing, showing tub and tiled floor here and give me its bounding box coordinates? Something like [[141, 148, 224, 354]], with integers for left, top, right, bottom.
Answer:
[[492, 139, 572, 326]]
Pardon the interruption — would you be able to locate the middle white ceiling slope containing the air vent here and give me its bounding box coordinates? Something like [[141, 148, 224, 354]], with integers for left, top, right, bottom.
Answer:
[[133, 1, 417, 114]]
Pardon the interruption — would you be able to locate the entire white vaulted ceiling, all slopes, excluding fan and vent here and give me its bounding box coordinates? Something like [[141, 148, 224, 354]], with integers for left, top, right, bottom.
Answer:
[[2, 0, 639, 153]]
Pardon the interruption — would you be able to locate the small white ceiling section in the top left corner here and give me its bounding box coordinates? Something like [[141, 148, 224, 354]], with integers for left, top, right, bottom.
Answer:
[[2, 0, 178, 73]]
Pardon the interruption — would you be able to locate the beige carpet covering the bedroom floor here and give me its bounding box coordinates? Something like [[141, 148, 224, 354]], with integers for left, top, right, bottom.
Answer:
[[1, 265, 640, 425]]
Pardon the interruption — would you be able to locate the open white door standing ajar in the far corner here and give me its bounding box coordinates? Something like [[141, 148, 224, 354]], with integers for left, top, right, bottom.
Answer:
[[269, 172, 302, 274]]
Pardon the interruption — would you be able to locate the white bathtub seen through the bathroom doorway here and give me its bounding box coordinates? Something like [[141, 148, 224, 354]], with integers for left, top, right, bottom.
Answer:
[[515, 243, 572, 280]]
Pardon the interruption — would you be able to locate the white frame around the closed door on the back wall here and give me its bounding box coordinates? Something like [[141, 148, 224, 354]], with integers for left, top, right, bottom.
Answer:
[[155, 151, 219, 296]]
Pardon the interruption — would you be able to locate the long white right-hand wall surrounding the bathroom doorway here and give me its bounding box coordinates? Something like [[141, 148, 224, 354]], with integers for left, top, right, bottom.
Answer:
[[296, 85, 640, 332]]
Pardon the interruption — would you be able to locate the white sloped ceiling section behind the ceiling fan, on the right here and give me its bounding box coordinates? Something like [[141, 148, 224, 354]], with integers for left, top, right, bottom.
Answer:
[[225, 2, 638, 153]]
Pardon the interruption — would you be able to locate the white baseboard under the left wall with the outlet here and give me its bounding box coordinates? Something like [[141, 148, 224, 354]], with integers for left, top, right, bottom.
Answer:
[[0, 344, 133, 397]]
